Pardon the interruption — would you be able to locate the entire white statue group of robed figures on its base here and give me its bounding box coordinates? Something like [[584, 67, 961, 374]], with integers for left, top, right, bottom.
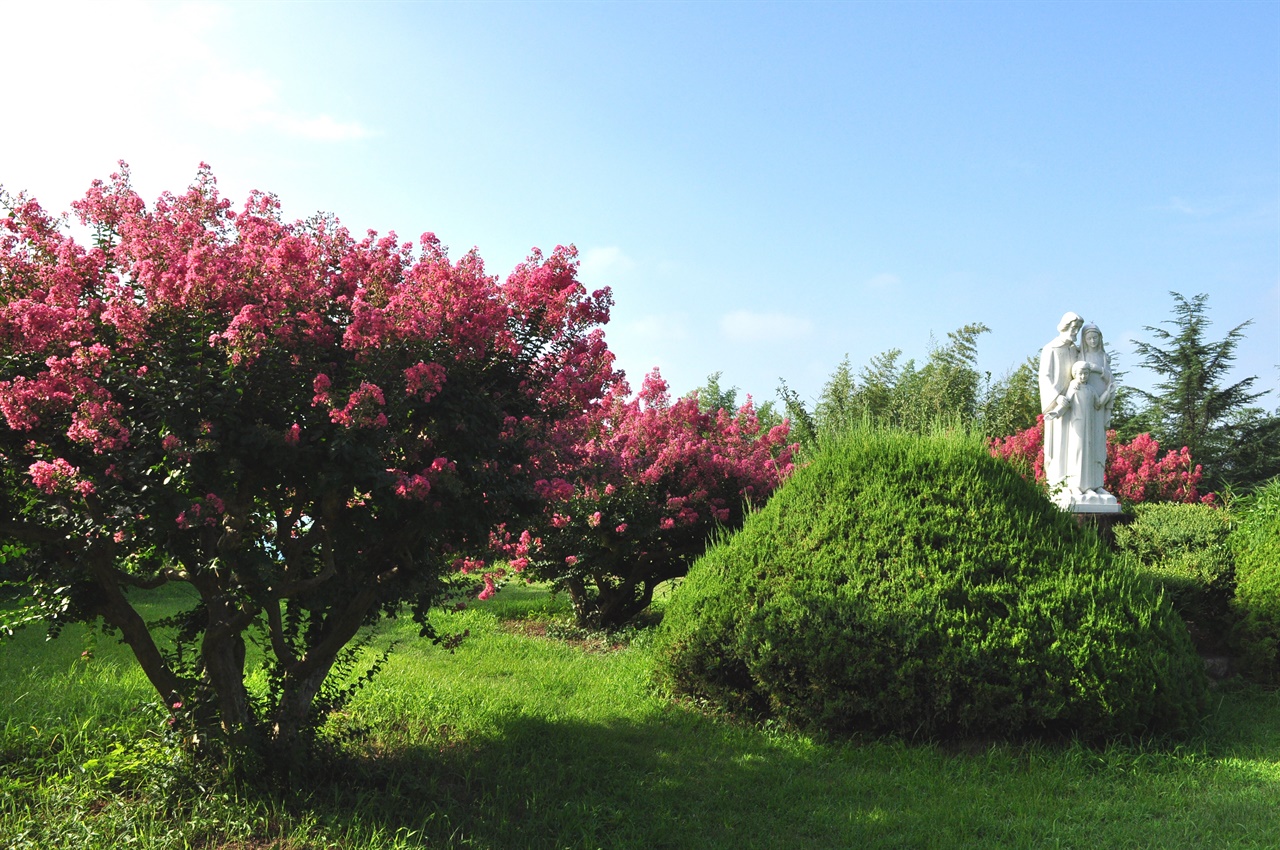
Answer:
[[1039, 312, 1120, 513]]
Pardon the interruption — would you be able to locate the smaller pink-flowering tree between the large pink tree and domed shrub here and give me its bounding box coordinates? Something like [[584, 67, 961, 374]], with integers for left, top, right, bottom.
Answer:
[[524, 370, 796, 627]]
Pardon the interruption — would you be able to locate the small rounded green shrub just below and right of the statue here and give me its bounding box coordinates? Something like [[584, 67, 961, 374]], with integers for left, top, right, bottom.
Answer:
[[1115, 502, 1235, 650]]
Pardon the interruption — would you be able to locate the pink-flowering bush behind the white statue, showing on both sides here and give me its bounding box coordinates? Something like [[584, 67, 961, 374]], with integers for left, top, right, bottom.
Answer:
[[991, 416, 1213, 504]]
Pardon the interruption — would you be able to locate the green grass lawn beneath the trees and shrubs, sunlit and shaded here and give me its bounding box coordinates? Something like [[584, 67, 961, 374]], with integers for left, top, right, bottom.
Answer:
[[0, 586, 1280, 850]]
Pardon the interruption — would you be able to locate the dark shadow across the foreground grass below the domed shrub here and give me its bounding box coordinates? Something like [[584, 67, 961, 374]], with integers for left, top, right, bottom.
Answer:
[[257, 699, 1280, 850]]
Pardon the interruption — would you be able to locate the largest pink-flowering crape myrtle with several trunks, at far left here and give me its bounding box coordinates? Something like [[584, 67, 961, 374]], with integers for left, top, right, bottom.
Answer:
[[0, 164, 620, 749]]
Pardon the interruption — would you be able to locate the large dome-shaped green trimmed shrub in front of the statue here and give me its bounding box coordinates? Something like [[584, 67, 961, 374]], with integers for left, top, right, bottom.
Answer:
[[655, 429, 1207, 739]]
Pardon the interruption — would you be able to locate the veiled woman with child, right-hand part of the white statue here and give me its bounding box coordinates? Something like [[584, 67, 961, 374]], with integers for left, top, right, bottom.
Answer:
[[1065, 323, 1115, 497]]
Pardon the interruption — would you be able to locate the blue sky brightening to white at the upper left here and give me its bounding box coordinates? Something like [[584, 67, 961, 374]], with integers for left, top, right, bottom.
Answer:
[[0, 0, 1280, 408]]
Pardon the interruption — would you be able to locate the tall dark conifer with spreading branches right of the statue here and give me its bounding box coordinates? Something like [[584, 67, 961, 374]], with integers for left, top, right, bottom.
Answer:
[[1134, 292, 1266, 488]]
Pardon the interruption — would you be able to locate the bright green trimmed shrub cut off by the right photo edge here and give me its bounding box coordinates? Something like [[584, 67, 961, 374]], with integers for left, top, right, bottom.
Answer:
[[1230, 477, 1280, 684]]
